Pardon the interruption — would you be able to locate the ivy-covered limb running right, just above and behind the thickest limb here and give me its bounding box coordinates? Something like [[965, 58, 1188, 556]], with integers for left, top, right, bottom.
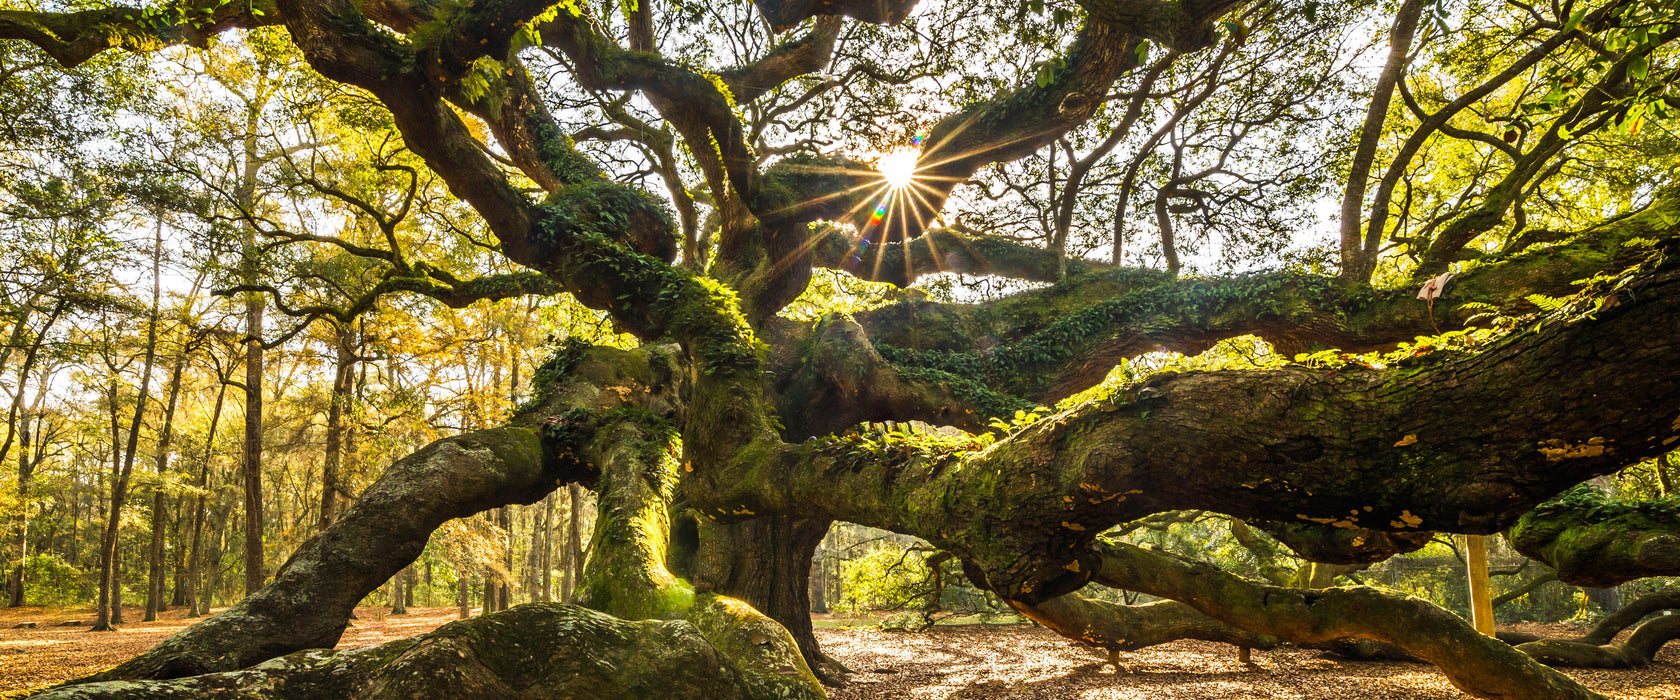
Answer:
[[857, 191, 1680, 403]]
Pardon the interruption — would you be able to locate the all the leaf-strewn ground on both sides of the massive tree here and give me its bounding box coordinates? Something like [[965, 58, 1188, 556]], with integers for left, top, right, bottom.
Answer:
[[0, 608, 1680, 700]]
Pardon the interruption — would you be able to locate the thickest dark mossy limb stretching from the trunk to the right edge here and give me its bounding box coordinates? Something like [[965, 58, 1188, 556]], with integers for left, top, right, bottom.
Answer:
[[685, 243, 1680, 603]]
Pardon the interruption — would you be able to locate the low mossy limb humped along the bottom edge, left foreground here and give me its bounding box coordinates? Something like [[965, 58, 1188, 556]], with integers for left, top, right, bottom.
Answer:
[[37, 603, 772, 700]]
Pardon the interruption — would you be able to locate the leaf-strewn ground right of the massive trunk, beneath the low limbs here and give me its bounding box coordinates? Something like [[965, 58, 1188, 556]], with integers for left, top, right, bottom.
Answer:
[[816, 624, 1680, 700]]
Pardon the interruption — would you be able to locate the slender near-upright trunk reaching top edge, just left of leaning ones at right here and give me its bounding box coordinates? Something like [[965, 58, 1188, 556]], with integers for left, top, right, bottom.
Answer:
[[1341, 0, 1423, 282]]
